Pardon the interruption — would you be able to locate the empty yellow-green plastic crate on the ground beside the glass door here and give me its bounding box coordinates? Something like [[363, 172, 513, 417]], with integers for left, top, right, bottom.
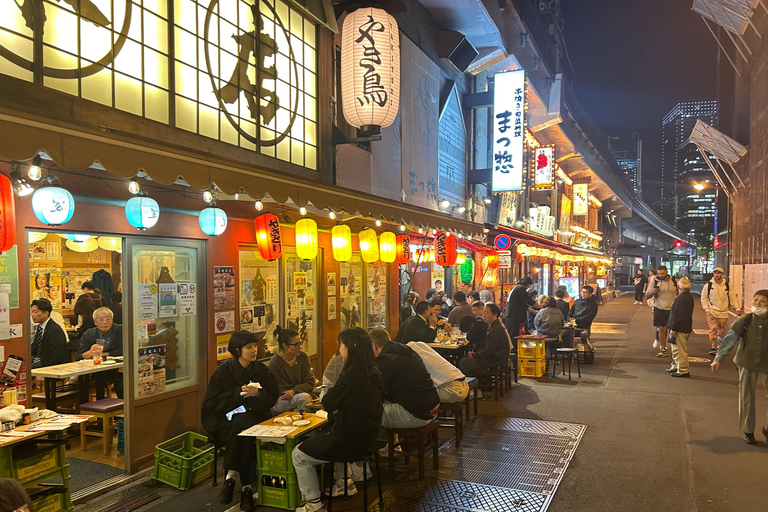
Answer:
[[152, 432, 214, 491]]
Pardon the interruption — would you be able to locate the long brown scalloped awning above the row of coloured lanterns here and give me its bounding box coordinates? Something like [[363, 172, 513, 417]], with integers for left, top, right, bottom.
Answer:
[[0, 111, 483, 237]]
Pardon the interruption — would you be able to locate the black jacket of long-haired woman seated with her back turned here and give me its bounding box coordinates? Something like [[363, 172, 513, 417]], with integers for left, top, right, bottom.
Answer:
[[301, 366, 384, 462]]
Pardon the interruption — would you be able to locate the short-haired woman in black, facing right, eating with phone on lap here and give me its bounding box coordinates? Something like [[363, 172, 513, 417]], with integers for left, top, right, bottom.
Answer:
[[202, 331, 278, 511]]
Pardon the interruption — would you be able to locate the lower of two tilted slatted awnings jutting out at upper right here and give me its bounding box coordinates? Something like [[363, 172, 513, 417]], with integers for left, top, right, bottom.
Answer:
[[689, 119, 747, 194]]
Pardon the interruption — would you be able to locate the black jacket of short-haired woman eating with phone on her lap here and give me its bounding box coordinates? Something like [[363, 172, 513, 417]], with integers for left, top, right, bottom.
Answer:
[[201, 358, 278, 441]]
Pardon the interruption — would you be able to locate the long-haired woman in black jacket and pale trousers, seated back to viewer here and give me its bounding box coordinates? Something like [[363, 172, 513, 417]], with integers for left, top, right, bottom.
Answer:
[[292, 327, 384, 512]]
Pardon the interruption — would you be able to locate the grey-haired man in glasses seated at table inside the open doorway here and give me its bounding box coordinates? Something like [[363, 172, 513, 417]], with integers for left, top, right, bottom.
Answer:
[[77, 307, 123, 398]]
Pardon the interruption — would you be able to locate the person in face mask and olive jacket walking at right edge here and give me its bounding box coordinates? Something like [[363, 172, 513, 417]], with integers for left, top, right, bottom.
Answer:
[[711, 290, 768, 444]]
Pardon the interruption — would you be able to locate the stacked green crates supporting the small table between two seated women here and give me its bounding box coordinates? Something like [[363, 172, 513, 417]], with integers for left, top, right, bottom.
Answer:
[[256, 438, 301, 510]]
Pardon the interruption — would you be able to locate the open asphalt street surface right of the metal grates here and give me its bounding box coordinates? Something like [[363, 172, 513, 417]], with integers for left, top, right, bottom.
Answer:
[[84, 294, 768, 512]]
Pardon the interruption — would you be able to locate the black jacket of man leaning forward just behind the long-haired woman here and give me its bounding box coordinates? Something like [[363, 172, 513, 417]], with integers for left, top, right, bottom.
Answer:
[[376, 339, 440, 419]]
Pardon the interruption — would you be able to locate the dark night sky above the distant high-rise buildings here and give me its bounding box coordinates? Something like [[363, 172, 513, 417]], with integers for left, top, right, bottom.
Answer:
[[561, 0, 718, 204]]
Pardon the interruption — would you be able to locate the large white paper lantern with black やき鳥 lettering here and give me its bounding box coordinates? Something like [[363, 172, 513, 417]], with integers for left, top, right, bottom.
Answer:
[[341, 7, 400, 131]]
